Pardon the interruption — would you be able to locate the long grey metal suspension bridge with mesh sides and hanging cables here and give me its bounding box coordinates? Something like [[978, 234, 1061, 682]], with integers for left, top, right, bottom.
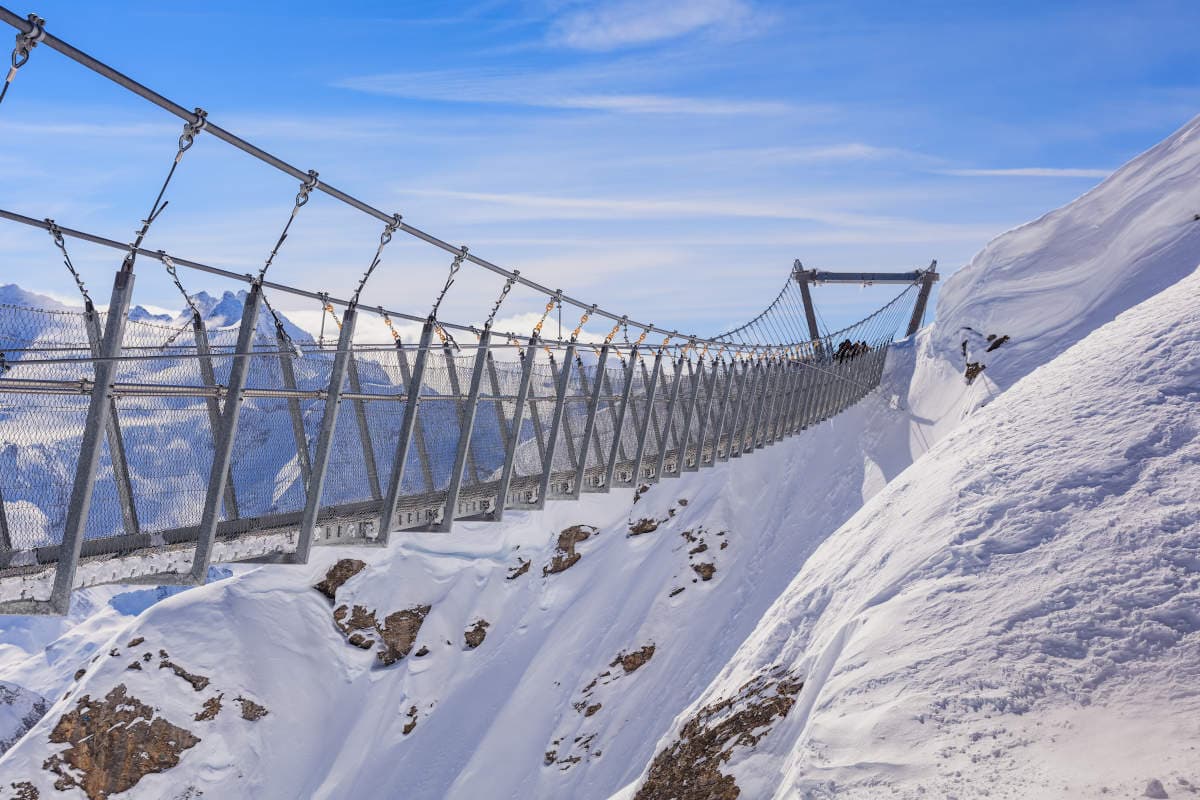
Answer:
[[0, 7, 937, 614]]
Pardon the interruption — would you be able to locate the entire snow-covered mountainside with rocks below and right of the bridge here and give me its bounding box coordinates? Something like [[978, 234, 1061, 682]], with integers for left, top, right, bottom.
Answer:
[[0, 113, 1200, 799]]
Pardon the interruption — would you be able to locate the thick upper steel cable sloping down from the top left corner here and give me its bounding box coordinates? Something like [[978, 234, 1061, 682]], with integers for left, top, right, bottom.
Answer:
[[0, 6, 768, 342]]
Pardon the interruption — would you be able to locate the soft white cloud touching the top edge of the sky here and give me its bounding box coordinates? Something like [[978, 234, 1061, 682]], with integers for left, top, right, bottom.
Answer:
[[548, 0, 757, 50]]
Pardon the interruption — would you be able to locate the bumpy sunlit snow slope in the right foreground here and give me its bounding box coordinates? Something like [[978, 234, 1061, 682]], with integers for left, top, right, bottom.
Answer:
[[630, 263, 1200, 798]]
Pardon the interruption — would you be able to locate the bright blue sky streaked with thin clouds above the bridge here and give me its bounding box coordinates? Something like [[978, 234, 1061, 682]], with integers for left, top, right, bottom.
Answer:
[[0, 0, 1200, 332]]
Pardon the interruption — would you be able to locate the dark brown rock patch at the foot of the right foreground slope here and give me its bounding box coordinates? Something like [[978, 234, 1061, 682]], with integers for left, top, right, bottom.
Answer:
[[635, 670, 804, 800]]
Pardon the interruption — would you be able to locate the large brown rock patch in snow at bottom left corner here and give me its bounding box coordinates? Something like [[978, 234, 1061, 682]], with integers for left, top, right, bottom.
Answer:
[[42, 684, 200, 800]]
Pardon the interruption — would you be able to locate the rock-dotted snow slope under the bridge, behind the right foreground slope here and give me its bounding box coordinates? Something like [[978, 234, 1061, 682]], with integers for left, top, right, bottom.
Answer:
[[0, 113, 1200, 799]]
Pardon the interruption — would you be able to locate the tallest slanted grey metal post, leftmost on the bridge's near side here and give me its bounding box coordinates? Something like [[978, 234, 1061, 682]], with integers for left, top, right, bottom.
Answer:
[[49, 266, 133, 614]]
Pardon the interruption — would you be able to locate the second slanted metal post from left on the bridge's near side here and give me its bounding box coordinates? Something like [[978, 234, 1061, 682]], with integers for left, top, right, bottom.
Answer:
[[191, 283, 263, 583]]
